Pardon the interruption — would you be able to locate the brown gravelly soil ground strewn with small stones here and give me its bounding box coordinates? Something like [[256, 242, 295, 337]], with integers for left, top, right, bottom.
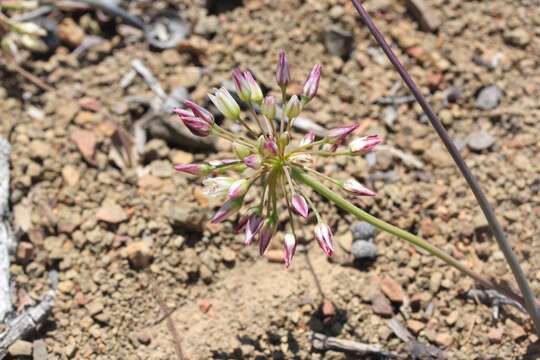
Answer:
[[0, 0, 540, 359]]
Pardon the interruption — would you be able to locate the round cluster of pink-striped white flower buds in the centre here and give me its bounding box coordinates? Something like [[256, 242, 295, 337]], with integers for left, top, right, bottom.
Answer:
[[175, 51, 382, 267]]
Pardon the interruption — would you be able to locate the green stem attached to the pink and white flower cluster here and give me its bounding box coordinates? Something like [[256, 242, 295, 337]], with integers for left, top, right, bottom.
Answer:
[[292, 169, 524, 305]]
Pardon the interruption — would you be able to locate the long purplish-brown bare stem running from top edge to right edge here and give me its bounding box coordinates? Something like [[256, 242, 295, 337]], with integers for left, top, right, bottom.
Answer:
[[351, 0, 540, 335]]
